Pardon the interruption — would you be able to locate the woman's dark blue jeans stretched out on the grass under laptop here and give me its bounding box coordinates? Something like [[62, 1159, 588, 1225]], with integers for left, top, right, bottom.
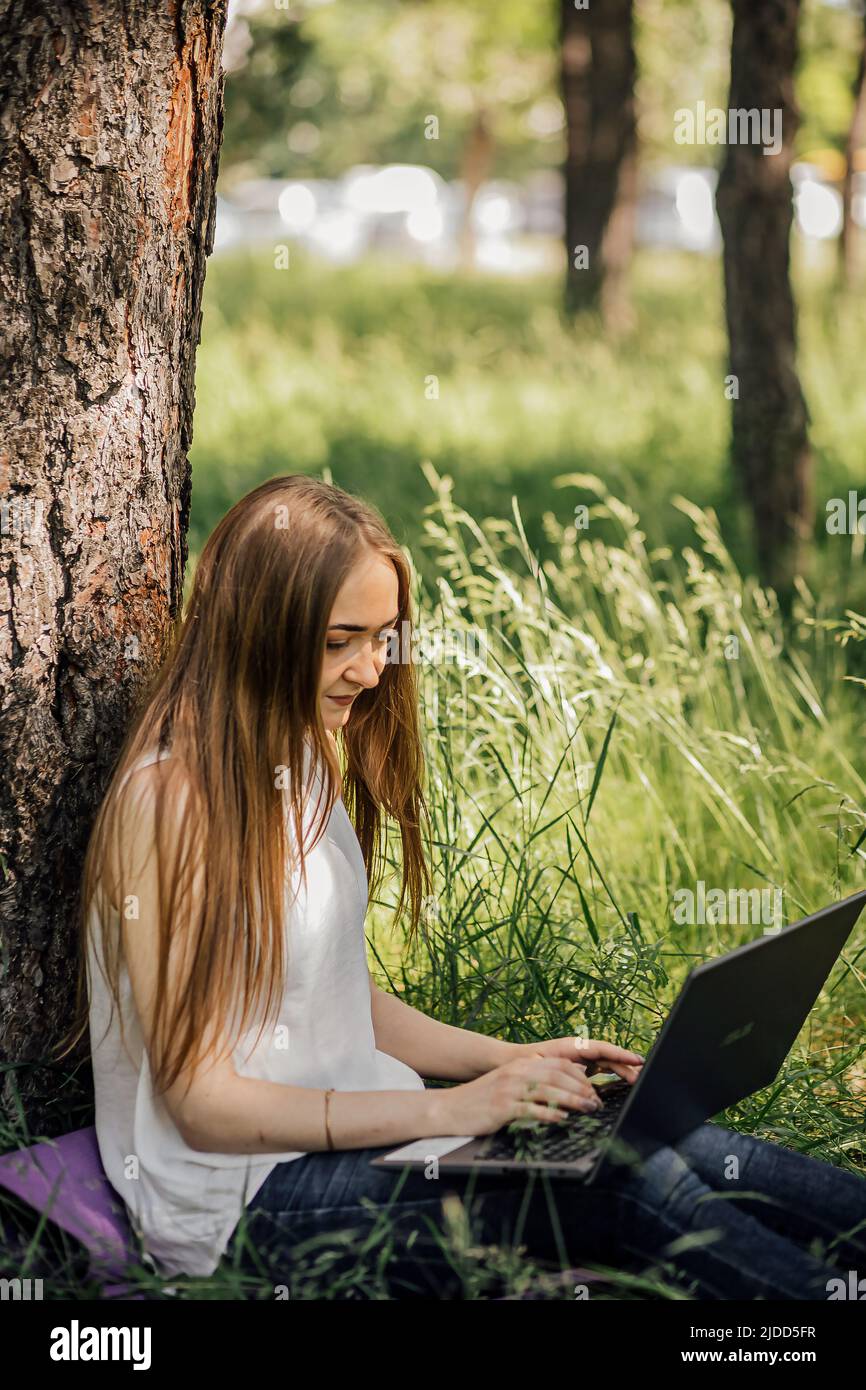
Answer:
[[227, 1122, 866, 1300]]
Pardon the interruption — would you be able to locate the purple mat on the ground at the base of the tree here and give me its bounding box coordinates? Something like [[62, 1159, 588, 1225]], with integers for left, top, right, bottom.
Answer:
[[0, 1126, 143, 1298]]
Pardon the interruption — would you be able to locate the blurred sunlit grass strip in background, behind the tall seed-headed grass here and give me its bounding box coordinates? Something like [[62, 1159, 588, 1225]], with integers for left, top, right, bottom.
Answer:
[[190, 239, 866, 608]]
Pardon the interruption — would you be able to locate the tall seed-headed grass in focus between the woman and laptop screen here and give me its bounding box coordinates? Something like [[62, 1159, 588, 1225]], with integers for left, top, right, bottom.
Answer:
[[373, 468, 866, 1172]]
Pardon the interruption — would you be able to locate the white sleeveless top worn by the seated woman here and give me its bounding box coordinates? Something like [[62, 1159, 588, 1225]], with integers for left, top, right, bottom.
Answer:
[[88, 748, 424, 1277]]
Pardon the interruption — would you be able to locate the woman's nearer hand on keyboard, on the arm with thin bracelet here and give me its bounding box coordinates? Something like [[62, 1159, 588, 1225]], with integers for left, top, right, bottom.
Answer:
[[436, 1056, 602, 1134]]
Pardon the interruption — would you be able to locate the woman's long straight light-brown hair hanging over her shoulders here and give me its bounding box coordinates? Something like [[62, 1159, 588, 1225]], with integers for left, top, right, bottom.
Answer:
[[55, 475, 431, 1091]]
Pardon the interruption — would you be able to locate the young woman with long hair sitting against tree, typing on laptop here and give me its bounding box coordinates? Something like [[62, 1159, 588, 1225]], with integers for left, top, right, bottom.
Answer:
[[71, 477, 866, 1298]]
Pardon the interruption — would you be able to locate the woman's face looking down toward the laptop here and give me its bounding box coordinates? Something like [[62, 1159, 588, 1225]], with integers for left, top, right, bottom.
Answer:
[[318, 553, 399, 731]]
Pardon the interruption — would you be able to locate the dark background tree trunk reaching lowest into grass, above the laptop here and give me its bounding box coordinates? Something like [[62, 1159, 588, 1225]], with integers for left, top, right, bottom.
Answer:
[[716, 0, 815, 595]]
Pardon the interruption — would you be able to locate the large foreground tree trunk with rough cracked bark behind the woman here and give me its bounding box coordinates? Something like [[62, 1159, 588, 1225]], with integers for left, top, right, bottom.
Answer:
[[0, 0, 225, 1127]]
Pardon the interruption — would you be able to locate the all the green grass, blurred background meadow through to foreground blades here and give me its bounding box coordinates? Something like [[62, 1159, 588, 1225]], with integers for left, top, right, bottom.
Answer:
[[0, 252, 866, 1298]]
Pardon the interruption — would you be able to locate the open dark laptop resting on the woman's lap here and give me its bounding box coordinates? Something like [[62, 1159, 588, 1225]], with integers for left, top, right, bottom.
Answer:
[[371, 890, 866, 1183]]
